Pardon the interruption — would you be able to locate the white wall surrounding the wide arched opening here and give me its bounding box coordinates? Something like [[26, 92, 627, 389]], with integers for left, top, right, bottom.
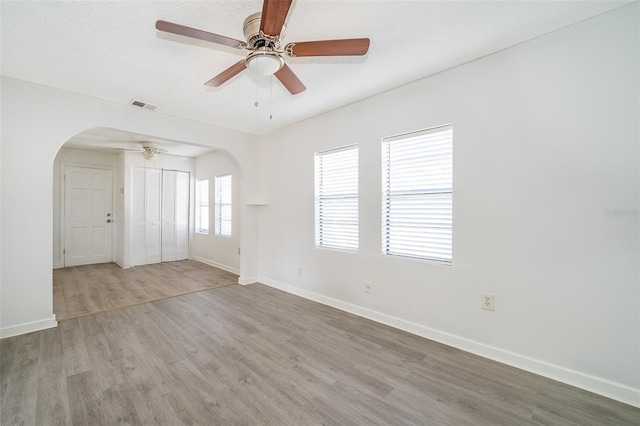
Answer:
[[0, 77, 258, 337]]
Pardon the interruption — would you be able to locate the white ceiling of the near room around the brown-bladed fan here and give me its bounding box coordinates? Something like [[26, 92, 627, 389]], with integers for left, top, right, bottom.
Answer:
[[0, 0, 629, 155]]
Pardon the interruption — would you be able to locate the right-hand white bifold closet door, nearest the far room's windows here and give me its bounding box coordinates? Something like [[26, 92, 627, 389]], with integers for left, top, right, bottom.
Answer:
[[162, 170, 189, 262]]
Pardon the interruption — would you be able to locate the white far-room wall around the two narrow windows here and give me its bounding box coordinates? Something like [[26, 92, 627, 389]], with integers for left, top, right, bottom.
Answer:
[[193, 151, 241, 273]]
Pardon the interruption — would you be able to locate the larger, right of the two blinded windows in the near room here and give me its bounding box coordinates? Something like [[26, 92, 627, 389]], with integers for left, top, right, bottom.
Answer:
[[382, 125, 453, 264]]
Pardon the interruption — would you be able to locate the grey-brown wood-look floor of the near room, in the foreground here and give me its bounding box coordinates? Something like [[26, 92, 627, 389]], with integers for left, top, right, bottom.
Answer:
[[0, 284, 640, 426]]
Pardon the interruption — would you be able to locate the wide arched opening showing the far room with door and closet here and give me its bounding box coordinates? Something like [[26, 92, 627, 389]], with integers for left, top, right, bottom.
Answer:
[[52, 128, 242, 320]]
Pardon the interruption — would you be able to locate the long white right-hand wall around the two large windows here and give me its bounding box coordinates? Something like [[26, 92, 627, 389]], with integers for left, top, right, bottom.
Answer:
[[259, 3, 640, 405]]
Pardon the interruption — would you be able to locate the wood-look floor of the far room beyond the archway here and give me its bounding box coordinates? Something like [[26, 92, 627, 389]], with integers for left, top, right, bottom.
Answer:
[[53, 260, 238, 321]]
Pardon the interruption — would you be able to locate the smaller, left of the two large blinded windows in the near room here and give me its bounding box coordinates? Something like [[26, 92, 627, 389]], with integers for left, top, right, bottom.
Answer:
[[315, 145, 358, 250]]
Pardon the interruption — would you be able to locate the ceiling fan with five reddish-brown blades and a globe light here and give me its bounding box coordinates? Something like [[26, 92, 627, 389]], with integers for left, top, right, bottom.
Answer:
[[156, 0, 369, 95]]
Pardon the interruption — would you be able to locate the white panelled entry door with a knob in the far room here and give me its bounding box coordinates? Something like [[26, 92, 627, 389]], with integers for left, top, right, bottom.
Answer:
[[63, 166, 113, 266]]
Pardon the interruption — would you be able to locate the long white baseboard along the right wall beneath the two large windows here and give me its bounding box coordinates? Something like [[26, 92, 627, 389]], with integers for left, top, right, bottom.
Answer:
[[258, 277, 640, 407]]
